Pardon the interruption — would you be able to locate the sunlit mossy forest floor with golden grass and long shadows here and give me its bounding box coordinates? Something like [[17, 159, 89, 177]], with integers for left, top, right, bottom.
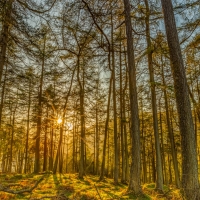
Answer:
[[0, 174, 182, 200]]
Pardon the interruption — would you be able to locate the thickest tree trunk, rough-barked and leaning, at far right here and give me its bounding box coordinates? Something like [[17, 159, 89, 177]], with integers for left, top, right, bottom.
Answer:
[[161, 0, 200, 200]]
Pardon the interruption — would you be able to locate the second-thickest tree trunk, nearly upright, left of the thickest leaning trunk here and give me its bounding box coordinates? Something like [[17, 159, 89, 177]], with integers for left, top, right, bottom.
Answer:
[[124, 0, 141, 194]]
